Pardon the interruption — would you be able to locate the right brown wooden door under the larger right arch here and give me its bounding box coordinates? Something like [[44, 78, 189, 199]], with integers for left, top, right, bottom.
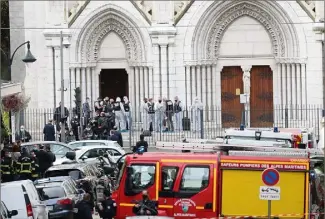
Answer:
[[250, 66, 273, 127]]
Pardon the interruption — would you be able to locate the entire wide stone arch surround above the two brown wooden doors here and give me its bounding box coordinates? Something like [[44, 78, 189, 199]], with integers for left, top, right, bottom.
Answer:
[[192, 0, 299, 60]]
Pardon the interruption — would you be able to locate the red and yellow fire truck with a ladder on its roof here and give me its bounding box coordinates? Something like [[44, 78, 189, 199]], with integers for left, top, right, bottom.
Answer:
[[112, 142, 324, 219]]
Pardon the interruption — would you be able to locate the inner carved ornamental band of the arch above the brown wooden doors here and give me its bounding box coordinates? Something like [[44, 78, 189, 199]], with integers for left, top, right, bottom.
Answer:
[[205, 3, 285, 59]]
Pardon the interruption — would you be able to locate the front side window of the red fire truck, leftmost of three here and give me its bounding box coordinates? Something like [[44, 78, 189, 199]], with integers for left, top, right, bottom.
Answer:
[[127, 164, 156, 191]]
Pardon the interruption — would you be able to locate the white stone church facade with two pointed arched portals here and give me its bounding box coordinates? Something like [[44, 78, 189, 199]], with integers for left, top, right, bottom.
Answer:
[[10, 0, 324, 126]]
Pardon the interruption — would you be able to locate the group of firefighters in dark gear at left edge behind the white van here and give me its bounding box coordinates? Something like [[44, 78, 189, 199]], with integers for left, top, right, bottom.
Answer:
[[1, 141, 56, 182]]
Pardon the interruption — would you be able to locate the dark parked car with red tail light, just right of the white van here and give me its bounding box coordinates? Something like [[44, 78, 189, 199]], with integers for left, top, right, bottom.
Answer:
[[34, 176, 83, 219]]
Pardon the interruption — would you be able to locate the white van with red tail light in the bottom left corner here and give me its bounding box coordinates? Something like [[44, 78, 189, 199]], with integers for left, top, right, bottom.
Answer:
[[1, 180, 48, 219]]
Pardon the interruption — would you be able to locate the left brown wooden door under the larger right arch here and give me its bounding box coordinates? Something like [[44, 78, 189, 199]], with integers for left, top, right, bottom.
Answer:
[[221, 66, 244, 128]]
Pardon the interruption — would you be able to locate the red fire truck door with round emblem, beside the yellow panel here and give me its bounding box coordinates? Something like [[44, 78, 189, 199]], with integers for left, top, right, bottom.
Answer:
[[173, 164, 216, 218]]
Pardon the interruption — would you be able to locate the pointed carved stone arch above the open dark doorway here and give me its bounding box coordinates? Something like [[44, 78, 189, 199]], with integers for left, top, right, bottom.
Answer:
[[77, 9, 145, 63]]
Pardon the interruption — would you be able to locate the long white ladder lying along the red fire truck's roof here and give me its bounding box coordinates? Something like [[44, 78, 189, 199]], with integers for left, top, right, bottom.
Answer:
[[156, 141, 324, 158]]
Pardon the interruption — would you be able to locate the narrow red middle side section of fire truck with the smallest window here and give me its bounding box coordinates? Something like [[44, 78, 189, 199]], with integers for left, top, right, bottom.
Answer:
[[158, 163, 182, 216]]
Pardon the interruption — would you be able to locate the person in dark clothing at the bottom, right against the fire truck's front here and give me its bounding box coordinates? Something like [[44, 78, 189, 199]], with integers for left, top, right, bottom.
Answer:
[[97, 190, 116, 219]]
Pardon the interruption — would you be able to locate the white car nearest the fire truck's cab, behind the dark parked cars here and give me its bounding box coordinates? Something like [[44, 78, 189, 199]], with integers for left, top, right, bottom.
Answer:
[[55, 145, 125, 164]]
